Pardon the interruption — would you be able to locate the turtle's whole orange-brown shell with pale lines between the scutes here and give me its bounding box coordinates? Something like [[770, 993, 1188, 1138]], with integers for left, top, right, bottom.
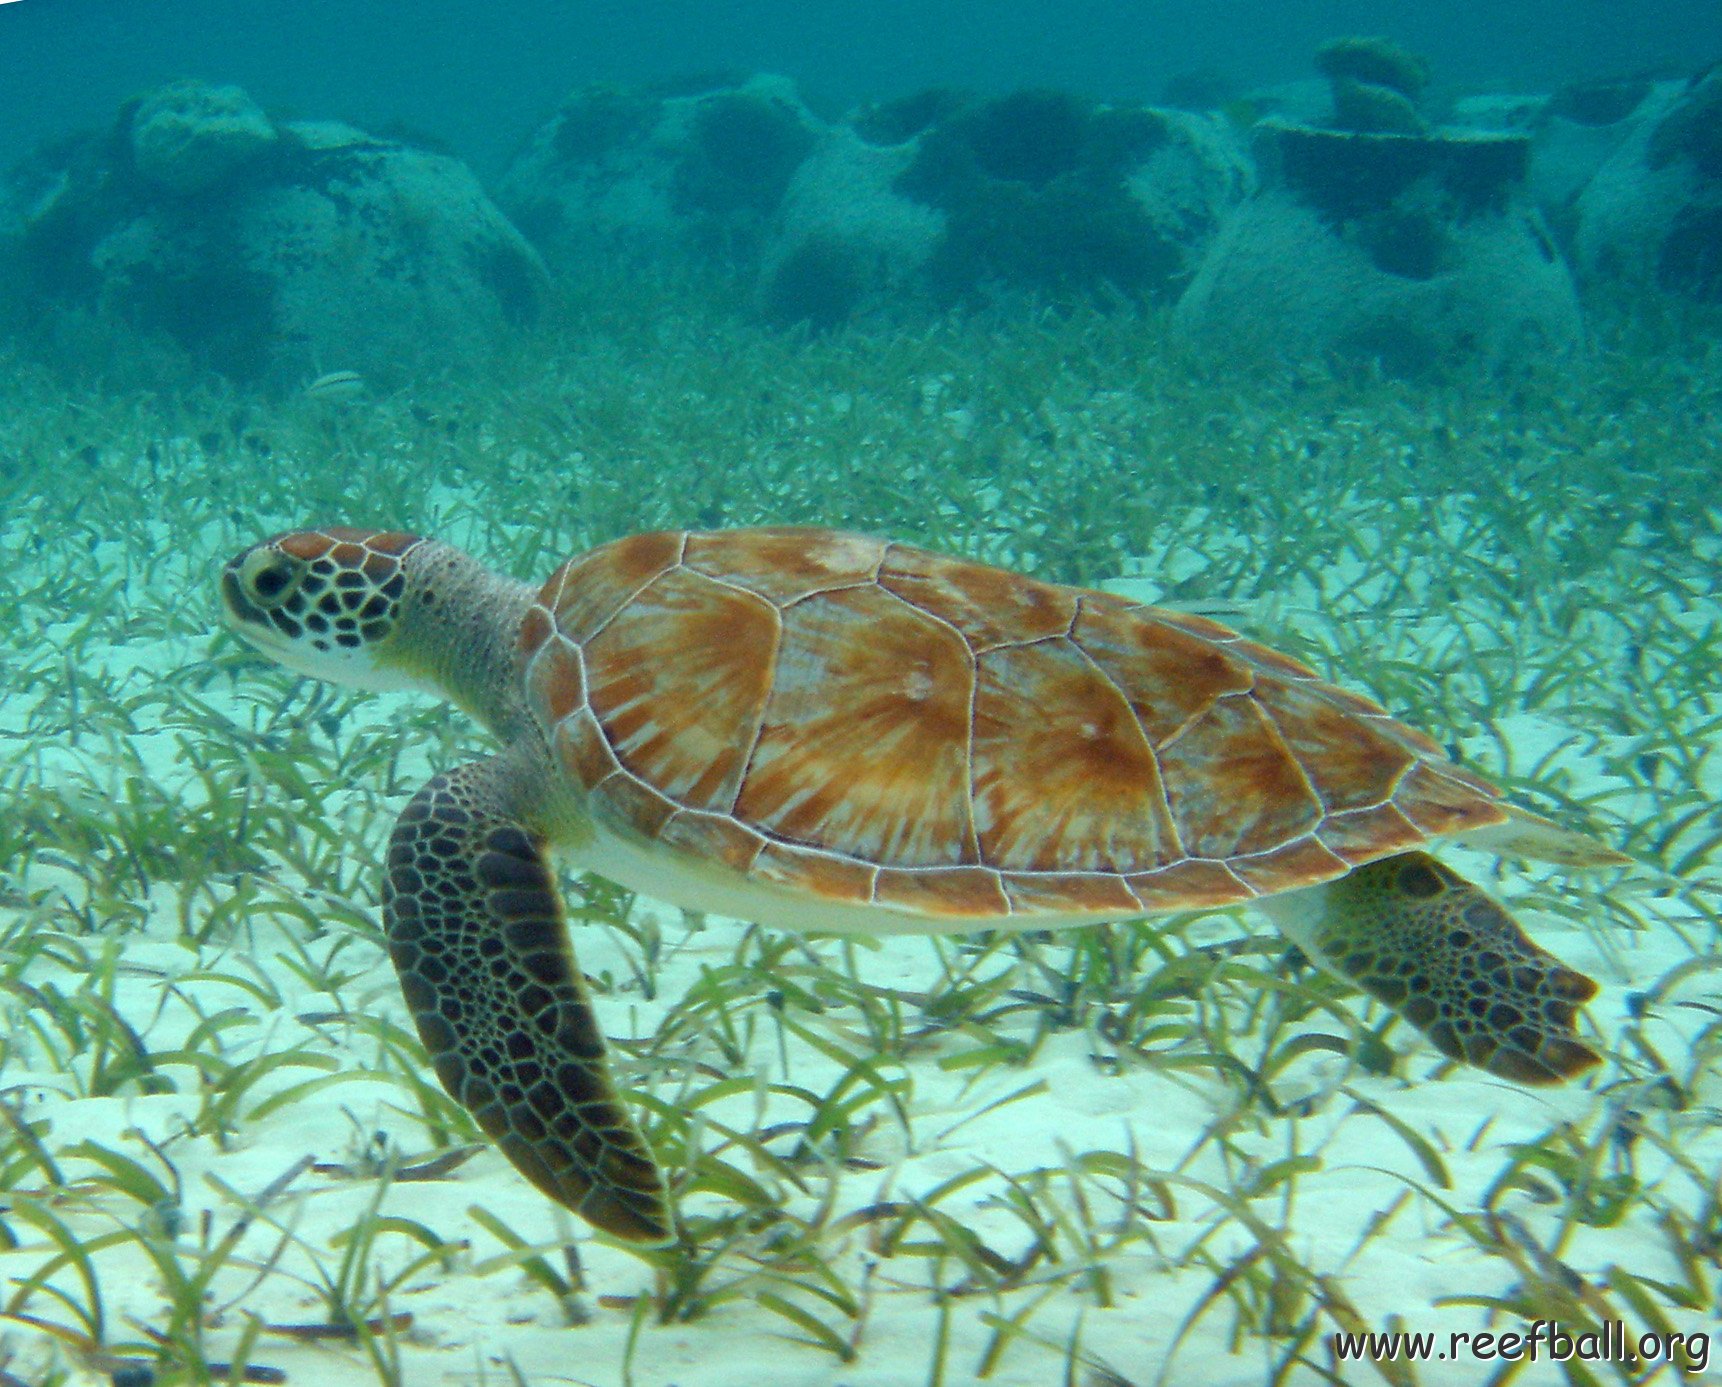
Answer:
[[522, 529, 1505, 920]]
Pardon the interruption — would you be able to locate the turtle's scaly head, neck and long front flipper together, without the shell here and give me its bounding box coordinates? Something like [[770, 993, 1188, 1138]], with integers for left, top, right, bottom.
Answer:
[[222, 529, 673, 1246]]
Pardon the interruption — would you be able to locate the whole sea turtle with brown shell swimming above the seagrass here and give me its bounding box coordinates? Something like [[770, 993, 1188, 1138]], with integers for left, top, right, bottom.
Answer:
[[220, 527, 1620, 1244]]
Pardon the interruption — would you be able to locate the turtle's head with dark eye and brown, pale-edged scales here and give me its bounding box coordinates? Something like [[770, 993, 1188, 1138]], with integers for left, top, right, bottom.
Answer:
[[220, 526, 430, 689]]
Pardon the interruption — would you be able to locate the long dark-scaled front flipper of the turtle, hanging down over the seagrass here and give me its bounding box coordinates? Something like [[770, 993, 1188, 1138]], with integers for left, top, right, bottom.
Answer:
[[384, 762, 673, 1244]]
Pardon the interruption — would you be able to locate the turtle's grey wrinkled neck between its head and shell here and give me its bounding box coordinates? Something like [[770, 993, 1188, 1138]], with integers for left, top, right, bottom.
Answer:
[[391, 539, 537, 743]]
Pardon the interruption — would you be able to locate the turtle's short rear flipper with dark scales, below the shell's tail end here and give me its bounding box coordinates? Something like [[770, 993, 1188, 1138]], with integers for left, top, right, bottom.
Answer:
[[1259, 853, 1601, 1084]]
